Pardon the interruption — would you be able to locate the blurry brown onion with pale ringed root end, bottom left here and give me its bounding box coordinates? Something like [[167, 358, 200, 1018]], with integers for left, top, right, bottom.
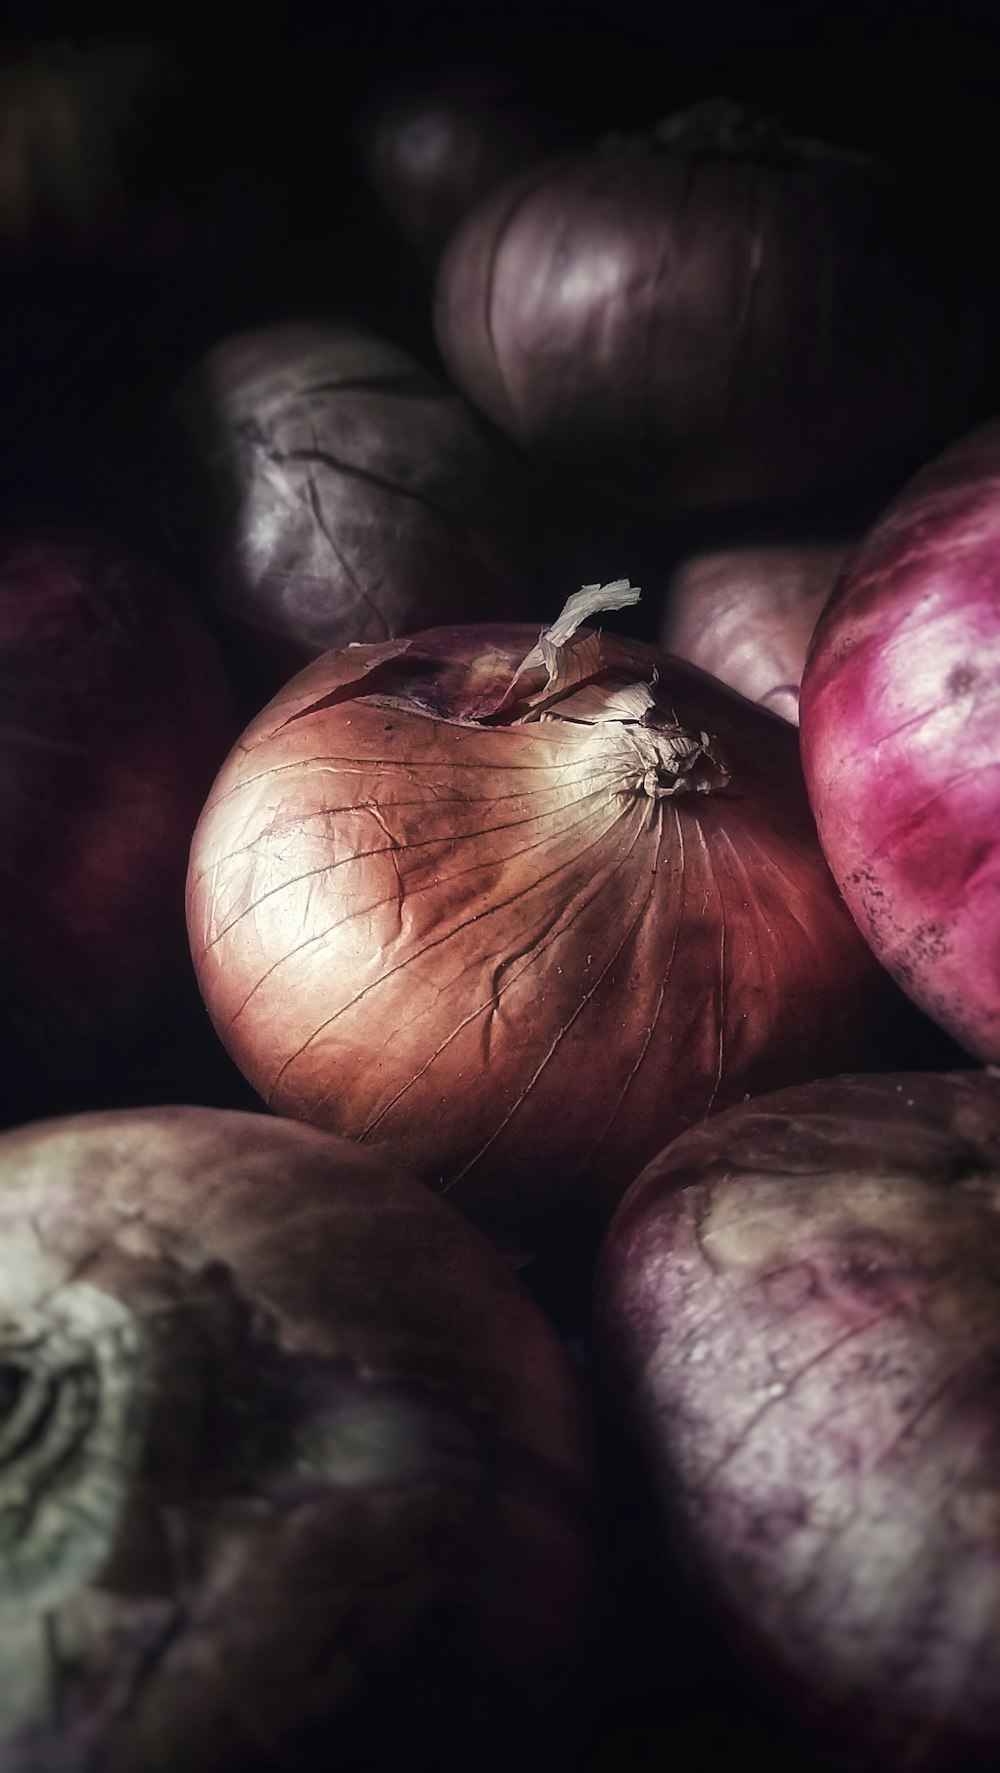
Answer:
[[0, 1108, 594, 1773]]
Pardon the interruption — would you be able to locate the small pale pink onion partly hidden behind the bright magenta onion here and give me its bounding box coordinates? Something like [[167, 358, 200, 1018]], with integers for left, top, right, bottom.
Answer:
[[660, 541, 849, 727]]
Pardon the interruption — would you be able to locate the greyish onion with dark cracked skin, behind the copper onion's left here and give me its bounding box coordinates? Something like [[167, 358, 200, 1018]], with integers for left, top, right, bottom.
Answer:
[[174, 319, 527, 695]]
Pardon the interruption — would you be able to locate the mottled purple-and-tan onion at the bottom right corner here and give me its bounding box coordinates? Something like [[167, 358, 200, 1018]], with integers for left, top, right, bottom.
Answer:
[[594, 1071, 1000, 1773]]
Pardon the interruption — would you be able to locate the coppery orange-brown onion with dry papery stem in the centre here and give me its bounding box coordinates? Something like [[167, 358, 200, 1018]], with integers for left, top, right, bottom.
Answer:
[[188, 599, 892, 1250]]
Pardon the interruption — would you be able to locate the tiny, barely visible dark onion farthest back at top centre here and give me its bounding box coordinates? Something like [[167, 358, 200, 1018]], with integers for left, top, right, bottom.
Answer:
[[355, 67, 539, 264]]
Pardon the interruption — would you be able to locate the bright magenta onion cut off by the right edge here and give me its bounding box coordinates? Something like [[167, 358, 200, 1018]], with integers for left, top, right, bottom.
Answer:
[[801, 422, 1000, 1060]]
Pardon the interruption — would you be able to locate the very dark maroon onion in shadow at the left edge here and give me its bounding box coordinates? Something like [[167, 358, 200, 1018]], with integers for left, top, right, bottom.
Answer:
[[0, 530, 236, 1046]]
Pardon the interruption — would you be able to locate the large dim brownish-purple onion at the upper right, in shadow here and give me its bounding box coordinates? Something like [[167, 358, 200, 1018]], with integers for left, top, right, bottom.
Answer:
[[436, 101, 993, 519]]
